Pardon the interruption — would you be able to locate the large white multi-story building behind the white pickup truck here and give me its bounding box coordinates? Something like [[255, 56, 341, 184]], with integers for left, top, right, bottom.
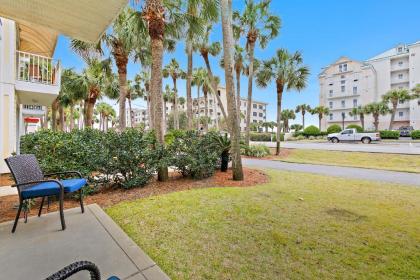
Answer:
[[319, 42, 420, 130]]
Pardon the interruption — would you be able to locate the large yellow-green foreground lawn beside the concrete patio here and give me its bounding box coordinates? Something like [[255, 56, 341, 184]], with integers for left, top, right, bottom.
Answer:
[[106, 171, 420, 279]]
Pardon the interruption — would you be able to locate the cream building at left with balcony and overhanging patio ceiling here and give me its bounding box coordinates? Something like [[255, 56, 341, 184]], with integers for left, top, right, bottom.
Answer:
[[0, 0, 127, 173]]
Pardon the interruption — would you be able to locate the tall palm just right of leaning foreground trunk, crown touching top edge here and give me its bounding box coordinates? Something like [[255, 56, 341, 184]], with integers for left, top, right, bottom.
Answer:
[[234, 0, 280, 145]]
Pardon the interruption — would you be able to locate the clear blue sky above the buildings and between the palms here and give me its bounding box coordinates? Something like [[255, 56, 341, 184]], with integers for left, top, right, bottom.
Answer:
[[54, 0, 420, 124]]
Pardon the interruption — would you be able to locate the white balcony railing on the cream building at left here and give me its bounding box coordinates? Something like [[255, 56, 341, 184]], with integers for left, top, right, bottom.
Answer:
[[16, 51, 61, 86]]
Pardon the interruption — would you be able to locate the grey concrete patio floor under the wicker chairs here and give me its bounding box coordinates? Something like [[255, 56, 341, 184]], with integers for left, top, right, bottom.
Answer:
[[0, 204, 169, 280]]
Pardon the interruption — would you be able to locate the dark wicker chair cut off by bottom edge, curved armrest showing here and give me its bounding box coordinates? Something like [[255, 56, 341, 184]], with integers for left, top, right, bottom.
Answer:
[[45, 261, 120, 280]]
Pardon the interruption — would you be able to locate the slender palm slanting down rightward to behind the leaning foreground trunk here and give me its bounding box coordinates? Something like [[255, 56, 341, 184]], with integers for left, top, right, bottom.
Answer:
[[193, 24, 227, 118]]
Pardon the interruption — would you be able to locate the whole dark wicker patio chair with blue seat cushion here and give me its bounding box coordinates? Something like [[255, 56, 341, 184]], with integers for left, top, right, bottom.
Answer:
[[5, 155, 87, 233]]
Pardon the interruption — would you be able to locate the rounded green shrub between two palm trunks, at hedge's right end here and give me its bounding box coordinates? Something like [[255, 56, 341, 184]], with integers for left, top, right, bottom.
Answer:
[[168, 131, 222, 179]]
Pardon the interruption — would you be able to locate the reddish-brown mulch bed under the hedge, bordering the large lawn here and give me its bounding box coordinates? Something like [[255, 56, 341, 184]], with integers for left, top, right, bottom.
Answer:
[[0, 168, 269, 222]]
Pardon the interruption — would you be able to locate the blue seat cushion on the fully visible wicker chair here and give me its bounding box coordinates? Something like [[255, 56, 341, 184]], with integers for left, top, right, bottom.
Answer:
[[21, 178, 87, 199]]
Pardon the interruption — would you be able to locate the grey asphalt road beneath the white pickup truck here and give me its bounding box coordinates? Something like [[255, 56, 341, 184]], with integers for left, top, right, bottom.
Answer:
[[252, 141, 420, 155]]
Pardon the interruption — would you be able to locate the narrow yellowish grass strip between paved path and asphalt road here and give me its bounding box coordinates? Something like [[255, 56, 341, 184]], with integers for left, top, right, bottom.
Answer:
[[274, 149, 420, 173]]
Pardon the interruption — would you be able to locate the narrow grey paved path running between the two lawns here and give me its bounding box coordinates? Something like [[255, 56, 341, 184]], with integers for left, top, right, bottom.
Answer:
[[242, 158, 420, 187]]
